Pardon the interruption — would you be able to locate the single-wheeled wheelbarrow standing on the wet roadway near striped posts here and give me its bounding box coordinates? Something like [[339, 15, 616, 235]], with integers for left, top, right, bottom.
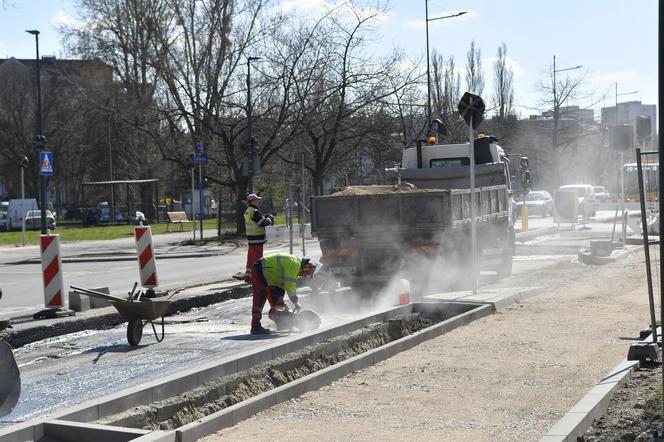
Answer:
[[71, 284, 181, 346]]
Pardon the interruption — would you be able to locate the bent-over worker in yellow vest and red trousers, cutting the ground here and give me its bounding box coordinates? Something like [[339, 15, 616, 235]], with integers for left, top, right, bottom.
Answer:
[[251, 253, 316, 335]]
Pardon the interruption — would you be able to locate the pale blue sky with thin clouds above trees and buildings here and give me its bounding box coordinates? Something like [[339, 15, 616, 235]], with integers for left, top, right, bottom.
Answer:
[[0, 0, 657, 118]]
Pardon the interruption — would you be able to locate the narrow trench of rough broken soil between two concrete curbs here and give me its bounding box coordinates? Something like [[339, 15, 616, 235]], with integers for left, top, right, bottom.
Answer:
[[94, 311, 448, 430]]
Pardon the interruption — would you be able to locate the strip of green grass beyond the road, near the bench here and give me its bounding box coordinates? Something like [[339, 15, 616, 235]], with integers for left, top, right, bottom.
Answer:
[[0, 219, 234, 245]]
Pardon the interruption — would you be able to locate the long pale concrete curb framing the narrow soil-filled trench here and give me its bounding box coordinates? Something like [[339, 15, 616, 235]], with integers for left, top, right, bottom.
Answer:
[[0, 302, 491, 442]]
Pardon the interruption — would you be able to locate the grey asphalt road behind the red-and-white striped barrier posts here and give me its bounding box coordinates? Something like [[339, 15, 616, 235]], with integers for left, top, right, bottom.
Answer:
[[0, 232, 320, 317]]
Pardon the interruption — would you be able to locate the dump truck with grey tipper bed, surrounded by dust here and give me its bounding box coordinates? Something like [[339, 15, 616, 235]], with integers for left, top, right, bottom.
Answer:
[[311, 137, 529, 291]]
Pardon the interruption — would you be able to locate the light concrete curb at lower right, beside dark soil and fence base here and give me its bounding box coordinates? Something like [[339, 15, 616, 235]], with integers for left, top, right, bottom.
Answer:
[[540, 359, 639, 442]]
